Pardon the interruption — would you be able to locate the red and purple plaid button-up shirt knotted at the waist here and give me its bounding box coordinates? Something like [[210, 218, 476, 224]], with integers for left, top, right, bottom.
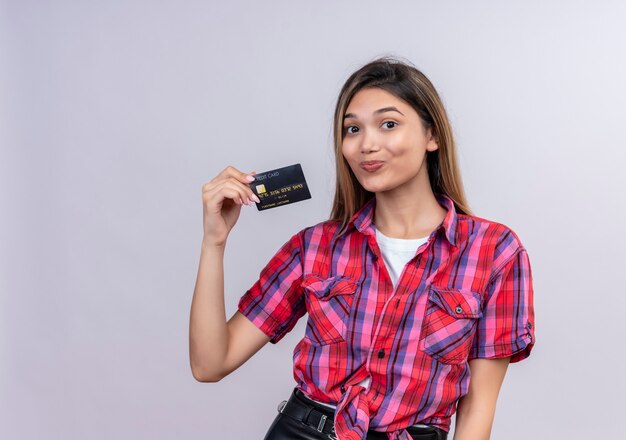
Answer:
[[239, 194, 535, 440]]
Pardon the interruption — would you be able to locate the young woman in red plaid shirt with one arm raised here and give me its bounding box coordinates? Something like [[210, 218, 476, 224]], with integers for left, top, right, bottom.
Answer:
[[190, 58, 535, 440]]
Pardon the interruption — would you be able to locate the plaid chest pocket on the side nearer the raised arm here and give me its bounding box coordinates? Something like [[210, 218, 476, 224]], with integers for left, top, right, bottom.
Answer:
[[302, 275, 358, 345]]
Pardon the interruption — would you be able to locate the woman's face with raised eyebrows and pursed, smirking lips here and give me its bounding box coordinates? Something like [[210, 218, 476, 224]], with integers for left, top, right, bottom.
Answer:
[[341, 88, 438, 193]]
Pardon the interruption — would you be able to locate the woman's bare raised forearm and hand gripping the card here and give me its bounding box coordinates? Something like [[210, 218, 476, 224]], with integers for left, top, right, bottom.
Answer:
[[189, 166, 270, 382]]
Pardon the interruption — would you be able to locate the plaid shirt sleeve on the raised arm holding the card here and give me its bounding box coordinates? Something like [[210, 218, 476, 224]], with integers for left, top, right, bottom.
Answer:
[[238, 231, 306, 344]]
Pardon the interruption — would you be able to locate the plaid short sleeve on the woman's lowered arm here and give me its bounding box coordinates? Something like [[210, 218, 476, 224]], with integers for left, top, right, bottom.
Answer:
[[468, 247, 535, 363]]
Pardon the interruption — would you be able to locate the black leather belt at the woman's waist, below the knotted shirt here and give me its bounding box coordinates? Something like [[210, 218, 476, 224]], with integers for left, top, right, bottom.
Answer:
[[278, 388, 447, 440]]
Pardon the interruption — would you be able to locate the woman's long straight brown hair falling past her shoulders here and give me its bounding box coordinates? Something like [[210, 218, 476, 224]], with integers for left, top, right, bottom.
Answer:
[[329, 56, 472, 235]]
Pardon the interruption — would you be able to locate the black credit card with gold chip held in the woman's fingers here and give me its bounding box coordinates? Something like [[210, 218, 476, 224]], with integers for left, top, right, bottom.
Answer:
[[248, 163, 311, 211]]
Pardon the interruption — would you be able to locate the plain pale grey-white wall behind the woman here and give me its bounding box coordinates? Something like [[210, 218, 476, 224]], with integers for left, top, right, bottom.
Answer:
[[0, 0, 626, 440]]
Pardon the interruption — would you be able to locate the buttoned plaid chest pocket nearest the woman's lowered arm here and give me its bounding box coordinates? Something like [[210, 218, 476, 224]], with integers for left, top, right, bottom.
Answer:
[[419, 286, 482, 364]]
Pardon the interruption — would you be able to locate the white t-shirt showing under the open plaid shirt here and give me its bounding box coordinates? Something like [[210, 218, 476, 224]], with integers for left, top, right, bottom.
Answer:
[[308, 226, 429, 422]]
